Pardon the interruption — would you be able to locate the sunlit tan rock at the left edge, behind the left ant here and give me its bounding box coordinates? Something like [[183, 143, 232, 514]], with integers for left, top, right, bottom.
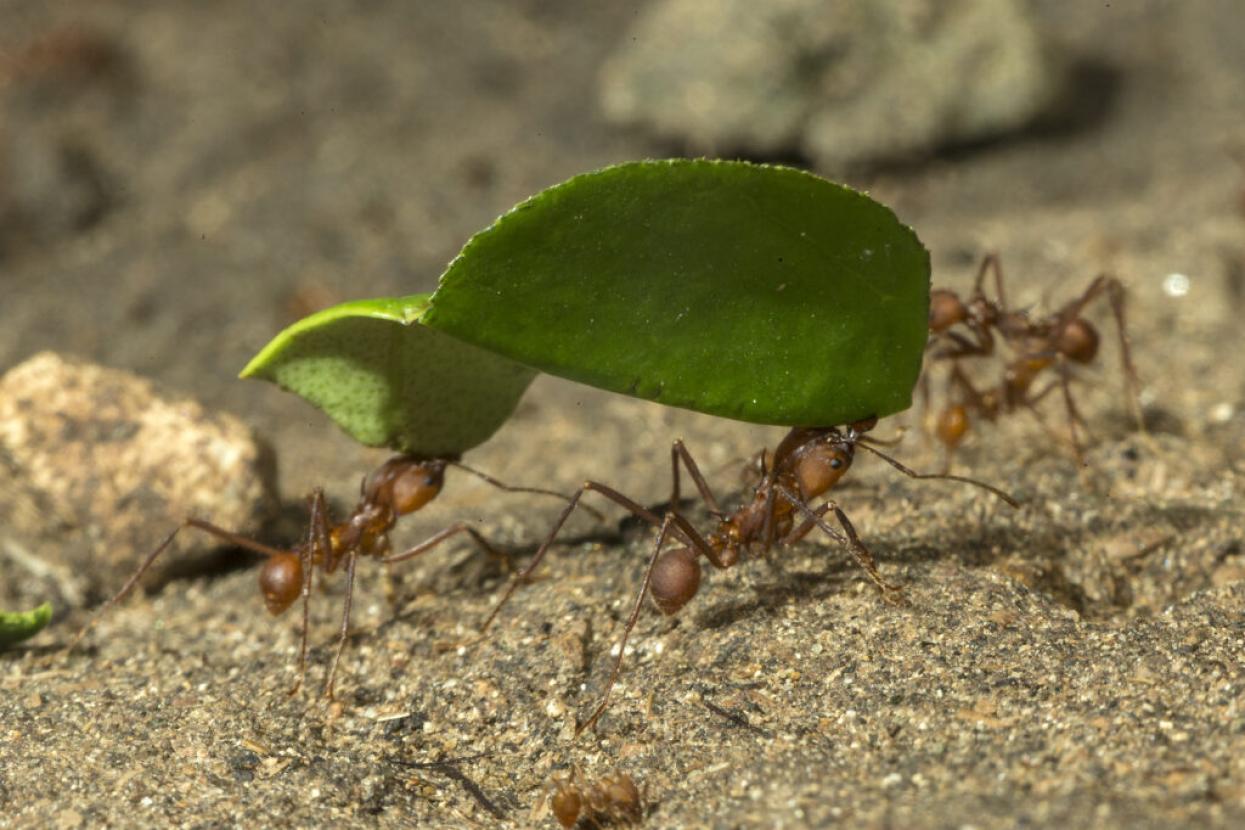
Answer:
[[0, 352, 275, 601]]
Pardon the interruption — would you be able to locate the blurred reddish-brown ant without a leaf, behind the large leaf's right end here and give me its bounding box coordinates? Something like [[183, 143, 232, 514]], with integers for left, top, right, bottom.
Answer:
[[925, 254, 1143, 467]]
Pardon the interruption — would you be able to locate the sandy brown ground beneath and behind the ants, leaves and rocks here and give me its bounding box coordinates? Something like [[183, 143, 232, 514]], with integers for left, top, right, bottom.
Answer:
[[0, 0, 1245, 828]]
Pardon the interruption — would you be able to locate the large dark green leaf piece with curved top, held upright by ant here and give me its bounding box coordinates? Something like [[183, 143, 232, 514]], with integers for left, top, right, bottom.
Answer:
[[423, 161, 929, 426]]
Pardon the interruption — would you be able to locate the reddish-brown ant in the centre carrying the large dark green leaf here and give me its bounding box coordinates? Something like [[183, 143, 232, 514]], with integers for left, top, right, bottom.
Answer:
[[482, 418, 1017, 733]]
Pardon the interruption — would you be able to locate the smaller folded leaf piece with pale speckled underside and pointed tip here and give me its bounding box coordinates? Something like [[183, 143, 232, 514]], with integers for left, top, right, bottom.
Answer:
[[242, 294, 535, 457]]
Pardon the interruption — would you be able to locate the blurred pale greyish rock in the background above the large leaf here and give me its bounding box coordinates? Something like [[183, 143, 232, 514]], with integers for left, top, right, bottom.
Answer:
[[601, 0, 1057, 169]]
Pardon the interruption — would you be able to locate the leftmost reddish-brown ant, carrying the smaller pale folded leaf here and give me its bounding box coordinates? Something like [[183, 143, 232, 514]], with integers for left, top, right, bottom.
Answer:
[[65, 455, 587, 698]]
